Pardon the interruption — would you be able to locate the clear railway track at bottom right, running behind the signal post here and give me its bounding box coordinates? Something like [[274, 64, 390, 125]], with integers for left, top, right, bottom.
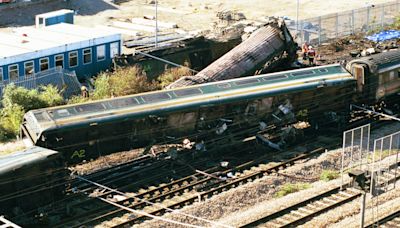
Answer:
[[241, 162, 400, 228]]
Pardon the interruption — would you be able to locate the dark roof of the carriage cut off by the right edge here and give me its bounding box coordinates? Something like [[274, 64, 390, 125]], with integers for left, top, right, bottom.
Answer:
[[349, 50, 400, 73]]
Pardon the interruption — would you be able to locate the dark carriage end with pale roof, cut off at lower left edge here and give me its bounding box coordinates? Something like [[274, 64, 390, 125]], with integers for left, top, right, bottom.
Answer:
[[0, 146, 68, 221]]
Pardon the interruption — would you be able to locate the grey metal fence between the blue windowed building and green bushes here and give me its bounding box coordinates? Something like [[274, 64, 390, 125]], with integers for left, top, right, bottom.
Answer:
[[0, 67, 81, 99]]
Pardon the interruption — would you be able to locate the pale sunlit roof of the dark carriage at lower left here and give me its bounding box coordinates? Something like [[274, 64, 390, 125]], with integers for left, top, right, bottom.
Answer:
[[0, 146, 58, 175]]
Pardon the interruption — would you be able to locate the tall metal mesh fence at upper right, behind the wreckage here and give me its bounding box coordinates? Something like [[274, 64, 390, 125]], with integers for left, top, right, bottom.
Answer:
[[289, 0, 400, 44]]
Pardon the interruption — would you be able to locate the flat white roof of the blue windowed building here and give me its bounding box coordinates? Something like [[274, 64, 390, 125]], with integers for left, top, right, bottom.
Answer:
[[0, 23, 121, 65]]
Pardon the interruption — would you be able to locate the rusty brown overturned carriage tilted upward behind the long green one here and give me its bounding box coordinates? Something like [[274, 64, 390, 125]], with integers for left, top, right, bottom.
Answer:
[[168, 19, 297, 88]]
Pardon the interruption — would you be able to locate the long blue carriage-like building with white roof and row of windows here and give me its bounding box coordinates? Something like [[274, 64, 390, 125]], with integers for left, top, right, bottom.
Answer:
[[0, 23, 121, 81]]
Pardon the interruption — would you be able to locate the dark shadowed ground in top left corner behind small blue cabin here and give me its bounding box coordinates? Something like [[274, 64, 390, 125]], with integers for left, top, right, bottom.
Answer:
[[0, 0, 117, 27]]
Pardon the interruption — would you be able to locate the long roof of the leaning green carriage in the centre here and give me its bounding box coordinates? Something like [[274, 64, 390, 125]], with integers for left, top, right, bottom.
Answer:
[[25, 64, 353, 141]]
